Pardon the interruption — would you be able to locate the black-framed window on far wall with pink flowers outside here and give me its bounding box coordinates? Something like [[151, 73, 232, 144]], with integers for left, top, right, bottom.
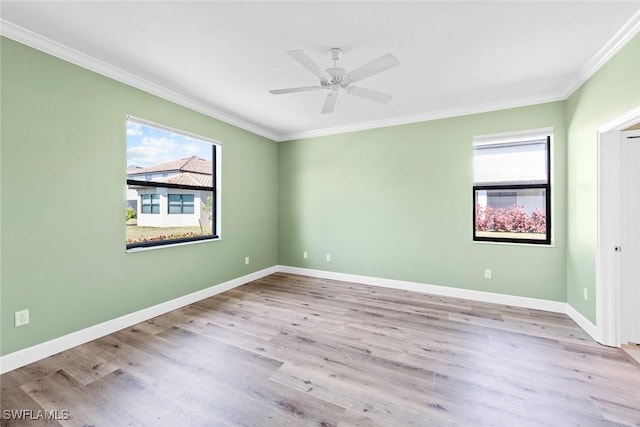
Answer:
[[473, 130, 551, 245]]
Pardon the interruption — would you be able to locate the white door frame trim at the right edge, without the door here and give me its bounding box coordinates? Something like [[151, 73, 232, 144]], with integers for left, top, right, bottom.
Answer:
[[596, 106, 640, 347]]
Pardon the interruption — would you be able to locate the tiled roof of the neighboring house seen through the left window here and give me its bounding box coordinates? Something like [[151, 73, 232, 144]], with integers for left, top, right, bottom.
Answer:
[[127, 156, 213, 187]]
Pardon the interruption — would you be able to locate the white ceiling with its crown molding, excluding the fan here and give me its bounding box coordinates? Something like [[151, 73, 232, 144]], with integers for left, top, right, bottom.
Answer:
[[0, 1, 640, 140]]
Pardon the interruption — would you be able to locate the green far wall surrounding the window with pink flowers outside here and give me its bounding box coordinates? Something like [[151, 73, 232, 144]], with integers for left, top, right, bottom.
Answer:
[[279, 102, 566, 301]]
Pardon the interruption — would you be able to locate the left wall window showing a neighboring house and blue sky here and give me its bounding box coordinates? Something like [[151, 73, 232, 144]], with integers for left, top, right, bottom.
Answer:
[[126, 117, 221, 249]]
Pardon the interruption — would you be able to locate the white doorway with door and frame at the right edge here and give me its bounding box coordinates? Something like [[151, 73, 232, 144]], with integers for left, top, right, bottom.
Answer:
[[594, 107, 640, 347]]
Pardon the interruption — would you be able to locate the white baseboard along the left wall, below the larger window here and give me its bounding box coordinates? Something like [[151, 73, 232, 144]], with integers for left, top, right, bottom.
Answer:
[[0, 266, 278, 374]]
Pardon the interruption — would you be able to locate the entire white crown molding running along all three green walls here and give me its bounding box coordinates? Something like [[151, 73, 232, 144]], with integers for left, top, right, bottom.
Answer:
[[0, 10, 640, 142]]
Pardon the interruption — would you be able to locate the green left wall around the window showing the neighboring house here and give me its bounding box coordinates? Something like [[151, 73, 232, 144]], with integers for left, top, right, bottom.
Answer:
[[0, 38, 278, 354]]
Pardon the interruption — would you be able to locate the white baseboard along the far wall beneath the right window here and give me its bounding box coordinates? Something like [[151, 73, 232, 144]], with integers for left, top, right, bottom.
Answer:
[[278, 265, 567, 313]]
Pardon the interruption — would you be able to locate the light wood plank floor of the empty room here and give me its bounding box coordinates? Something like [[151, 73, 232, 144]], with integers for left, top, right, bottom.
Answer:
[[0, 274, 640, 427]]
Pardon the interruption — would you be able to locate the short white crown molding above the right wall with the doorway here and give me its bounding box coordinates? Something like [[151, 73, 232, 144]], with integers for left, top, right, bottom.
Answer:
[[560, 10, 640, 99]]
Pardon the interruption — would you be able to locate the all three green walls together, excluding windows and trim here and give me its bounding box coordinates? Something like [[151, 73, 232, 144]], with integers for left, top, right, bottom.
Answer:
[[0, 30, 640, 355]]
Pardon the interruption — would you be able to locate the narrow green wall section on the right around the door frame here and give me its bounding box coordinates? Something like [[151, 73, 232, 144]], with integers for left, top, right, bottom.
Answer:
[[565, 35, 640, 323]]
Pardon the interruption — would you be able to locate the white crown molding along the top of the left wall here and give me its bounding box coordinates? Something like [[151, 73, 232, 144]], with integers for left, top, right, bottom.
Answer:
[[0, 19, 279, 141]]
